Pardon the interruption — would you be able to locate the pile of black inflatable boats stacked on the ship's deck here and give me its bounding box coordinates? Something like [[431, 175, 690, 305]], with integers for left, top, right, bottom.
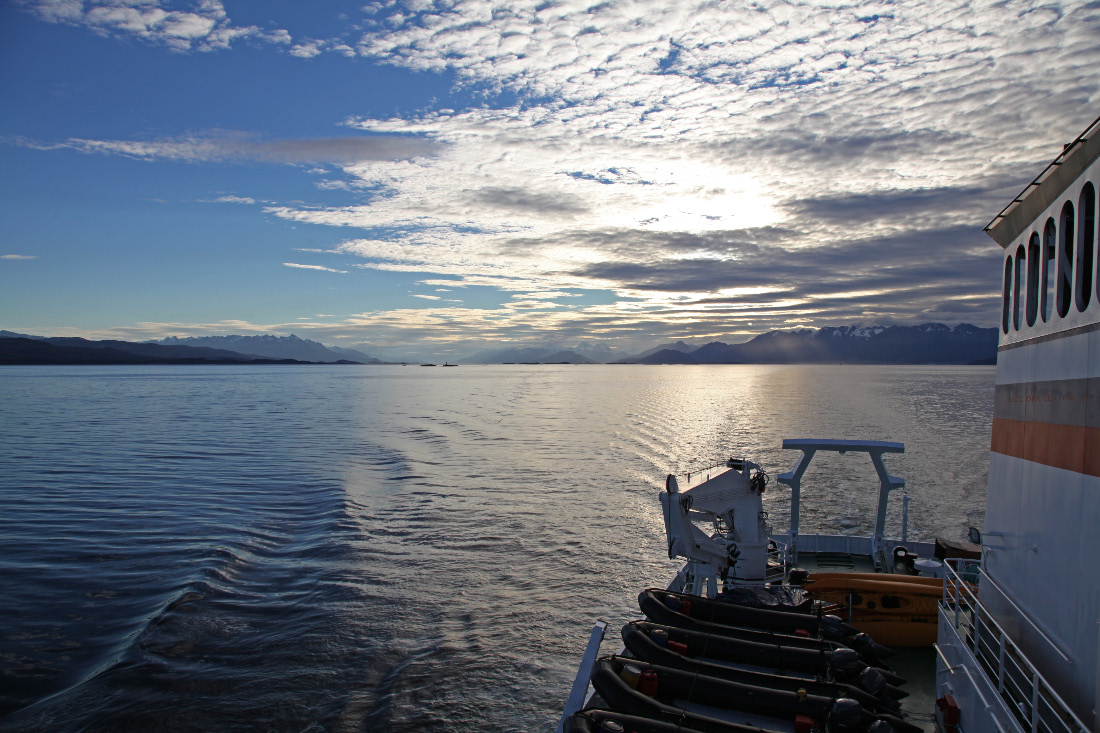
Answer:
[[571, 589, 920, 733]]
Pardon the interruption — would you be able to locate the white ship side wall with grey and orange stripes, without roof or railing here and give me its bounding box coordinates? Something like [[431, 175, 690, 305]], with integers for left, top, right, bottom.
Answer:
[[980, 158, 1100, 730]]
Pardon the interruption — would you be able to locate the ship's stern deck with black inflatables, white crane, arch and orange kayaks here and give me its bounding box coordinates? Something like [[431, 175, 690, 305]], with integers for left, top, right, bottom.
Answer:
[[561, 440, 943, 733]]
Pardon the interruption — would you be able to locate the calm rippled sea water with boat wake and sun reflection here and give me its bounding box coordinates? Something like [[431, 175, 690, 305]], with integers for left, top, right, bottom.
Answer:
[[0, 365, 993, 731]]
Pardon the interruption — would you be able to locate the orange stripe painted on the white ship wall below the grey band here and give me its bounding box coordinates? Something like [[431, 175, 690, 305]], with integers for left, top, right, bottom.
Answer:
[[990, 417, 1100, 477]]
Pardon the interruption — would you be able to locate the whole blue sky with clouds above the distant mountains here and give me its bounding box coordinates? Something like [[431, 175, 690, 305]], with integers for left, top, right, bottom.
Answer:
[[0, 0, 1100, 358]]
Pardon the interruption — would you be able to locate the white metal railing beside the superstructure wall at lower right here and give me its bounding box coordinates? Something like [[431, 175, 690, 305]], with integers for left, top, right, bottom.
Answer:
[[943, 560, 1089, 733]]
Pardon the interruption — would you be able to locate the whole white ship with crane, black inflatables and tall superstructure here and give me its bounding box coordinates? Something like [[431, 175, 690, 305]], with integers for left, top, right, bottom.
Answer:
[[558, 118, 1100, 733]]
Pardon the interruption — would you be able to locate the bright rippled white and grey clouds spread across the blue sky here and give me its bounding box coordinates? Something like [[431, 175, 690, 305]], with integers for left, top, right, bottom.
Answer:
[[12, 0, 1100, 352]]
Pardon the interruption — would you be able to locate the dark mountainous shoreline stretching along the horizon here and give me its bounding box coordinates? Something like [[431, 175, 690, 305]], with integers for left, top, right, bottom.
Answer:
[[0, 324, 998, 365]]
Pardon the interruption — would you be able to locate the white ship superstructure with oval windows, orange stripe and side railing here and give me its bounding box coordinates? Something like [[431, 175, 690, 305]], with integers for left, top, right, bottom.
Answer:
[[938, 114, 1100, 731]]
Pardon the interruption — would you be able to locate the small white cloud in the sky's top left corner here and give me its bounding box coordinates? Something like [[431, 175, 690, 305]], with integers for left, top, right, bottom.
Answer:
[[17, 0, 290, 52]]
